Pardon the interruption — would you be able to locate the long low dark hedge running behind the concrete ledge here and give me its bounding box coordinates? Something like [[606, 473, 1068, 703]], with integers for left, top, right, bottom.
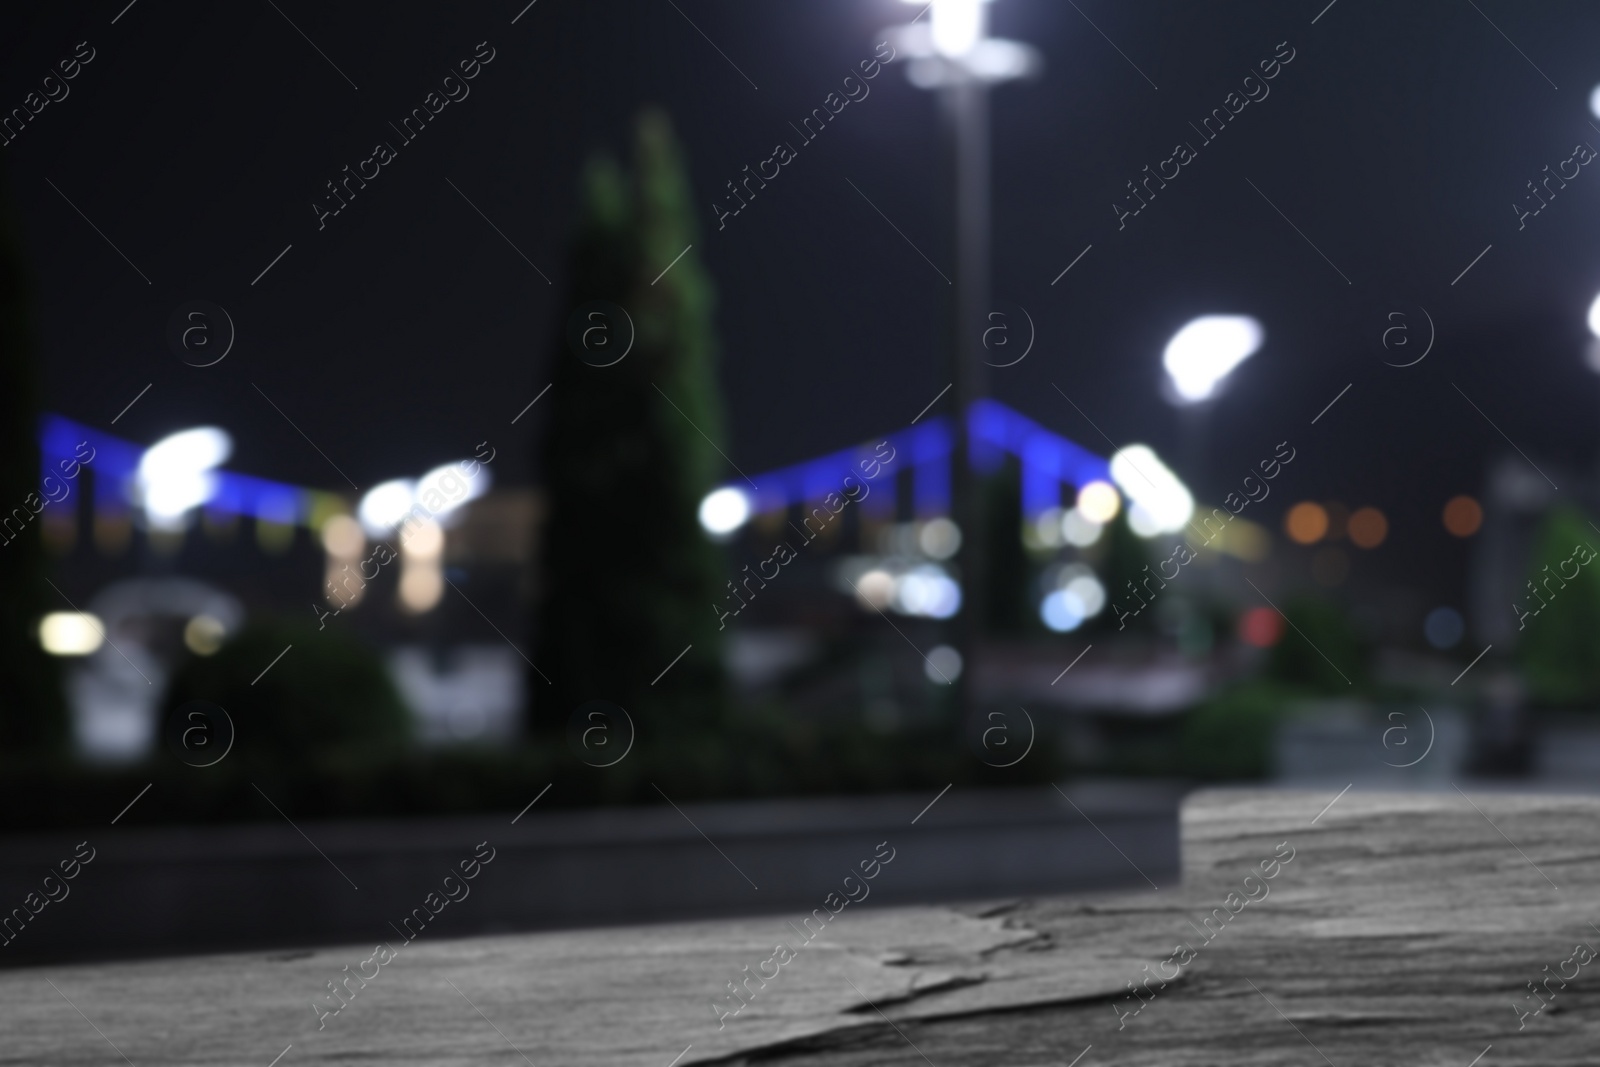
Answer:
[[0, 710, 1062, 829]]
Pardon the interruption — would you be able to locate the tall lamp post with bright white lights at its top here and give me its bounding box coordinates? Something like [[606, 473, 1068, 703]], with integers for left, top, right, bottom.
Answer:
[[893, 0, 1040, 717]]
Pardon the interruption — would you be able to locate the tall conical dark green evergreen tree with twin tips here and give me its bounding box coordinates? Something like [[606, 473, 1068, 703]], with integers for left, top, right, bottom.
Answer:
[[530, 110, 733, 742]]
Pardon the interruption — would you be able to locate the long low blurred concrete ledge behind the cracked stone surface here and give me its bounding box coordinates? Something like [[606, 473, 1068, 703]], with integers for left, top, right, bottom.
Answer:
[[0, 782, 1181, 966]]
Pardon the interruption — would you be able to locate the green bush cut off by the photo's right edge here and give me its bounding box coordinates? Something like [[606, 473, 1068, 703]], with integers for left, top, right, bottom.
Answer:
[[1512, 506, 1600, 709]]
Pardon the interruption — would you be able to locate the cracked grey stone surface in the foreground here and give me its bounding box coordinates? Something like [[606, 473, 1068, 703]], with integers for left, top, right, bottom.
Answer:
[[0, 790, 1600, 1067]]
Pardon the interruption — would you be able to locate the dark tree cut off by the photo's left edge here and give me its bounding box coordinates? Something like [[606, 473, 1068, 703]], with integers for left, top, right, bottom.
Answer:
[[0, 156, 69, 757]]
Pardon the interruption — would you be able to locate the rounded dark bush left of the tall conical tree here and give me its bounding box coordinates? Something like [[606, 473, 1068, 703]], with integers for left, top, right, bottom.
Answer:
[[162, 621, 411, 774]]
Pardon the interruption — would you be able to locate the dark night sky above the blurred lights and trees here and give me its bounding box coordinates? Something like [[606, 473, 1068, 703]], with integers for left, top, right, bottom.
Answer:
[[0, 0, 1600, 591]]
